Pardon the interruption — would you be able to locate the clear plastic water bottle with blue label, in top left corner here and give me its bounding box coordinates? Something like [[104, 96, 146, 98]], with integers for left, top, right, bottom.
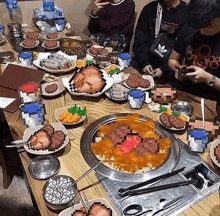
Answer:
[[5, 0, 23, 24]]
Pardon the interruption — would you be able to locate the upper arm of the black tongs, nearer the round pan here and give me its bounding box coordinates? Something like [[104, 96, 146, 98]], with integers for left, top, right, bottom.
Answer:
[[118, 167, 185, 196]]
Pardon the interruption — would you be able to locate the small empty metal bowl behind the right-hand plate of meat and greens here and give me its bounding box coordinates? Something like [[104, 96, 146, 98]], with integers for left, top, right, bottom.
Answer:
[[171, 101, 194, 116]]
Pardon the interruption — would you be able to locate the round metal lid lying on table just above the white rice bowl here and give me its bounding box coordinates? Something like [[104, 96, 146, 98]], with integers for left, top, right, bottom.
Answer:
[[29, 155, 60, 180]]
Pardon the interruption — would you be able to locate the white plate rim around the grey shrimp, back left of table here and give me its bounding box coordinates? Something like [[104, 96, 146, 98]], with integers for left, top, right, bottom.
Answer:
[[33, 51, 77, 73]]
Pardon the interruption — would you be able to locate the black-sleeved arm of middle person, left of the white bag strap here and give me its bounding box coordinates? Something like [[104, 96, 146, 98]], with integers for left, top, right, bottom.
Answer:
[[133, 5, 156, 72]]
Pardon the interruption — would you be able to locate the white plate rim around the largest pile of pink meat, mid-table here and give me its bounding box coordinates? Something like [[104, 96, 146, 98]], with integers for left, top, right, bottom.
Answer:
[[62, 66, 114, 97]]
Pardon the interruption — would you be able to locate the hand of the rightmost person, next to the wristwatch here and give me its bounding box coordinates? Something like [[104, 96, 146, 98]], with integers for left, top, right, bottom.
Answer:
[[185, 66, 212, 83]]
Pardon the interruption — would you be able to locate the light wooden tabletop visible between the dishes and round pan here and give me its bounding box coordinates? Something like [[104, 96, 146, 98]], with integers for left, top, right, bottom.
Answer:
[[0, 29, 220, 216]]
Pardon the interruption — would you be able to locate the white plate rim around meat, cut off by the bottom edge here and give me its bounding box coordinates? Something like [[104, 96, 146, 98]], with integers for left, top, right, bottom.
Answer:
[[58, 198, 118, 216]]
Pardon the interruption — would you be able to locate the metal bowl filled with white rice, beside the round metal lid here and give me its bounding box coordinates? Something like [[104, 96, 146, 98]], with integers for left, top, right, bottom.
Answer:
[[43, 175, 77, 210]]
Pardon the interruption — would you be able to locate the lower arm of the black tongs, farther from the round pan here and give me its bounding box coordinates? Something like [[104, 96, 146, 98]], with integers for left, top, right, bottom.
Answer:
[[120, 180, 195, 197]]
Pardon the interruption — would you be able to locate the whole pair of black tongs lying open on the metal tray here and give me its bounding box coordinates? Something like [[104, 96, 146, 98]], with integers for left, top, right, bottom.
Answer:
[[118, 167, 185, 197]]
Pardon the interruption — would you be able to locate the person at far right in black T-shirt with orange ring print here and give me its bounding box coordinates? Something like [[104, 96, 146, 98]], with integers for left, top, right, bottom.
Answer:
[[168, 0, 220, 119]]
